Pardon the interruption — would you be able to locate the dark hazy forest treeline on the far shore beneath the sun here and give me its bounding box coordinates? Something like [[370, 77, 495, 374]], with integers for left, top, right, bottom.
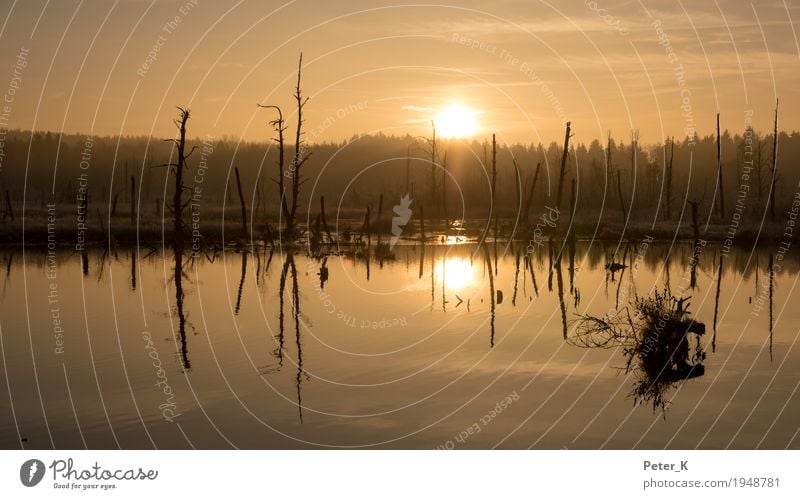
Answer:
[[0, 126, 800, 228]]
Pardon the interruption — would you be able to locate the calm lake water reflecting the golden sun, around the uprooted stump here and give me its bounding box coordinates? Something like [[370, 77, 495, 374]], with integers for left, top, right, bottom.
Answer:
[[0, 241, 800, 449]]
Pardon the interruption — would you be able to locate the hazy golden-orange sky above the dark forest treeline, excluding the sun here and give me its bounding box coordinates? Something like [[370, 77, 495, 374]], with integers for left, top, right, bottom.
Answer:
[[0, 0, 800, 142]]
